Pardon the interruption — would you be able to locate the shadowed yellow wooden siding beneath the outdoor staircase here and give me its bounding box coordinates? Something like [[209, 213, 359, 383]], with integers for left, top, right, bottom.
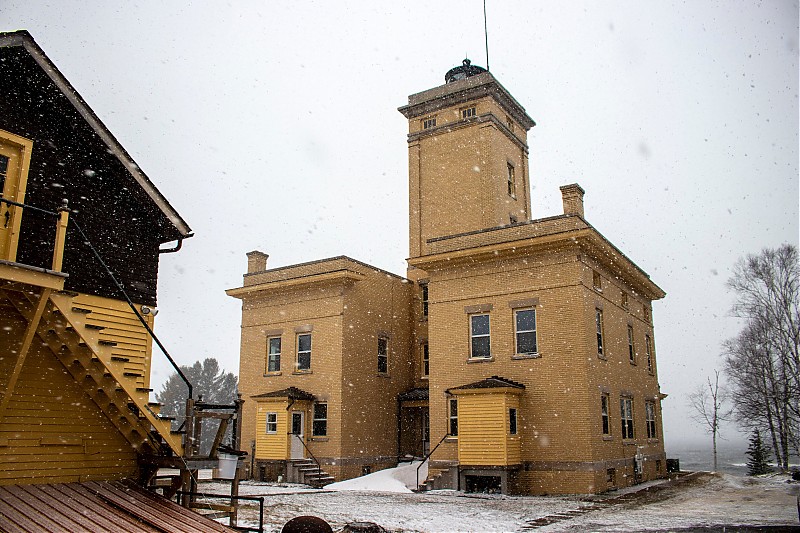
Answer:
[[0, 315, 137, 485]]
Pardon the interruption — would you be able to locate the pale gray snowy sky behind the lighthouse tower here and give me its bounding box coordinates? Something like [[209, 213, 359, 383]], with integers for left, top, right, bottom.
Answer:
[[0, 0, 798, 449]]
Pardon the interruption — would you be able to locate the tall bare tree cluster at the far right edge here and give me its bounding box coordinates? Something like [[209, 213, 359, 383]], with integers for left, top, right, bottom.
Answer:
[[724, 244, 800, 470]]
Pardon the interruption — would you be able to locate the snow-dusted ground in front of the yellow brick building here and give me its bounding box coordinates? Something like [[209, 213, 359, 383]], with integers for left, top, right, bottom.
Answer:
[[194, 465, 800, 533]]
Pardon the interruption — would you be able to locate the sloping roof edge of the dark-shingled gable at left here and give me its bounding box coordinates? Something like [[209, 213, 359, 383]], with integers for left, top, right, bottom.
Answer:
[[0, 30, 192, 238]]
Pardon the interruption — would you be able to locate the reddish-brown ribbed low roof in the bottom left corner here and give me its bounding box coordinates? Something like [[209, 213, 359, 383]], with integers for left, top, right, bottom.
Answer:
[[0, 481, 234, 533]]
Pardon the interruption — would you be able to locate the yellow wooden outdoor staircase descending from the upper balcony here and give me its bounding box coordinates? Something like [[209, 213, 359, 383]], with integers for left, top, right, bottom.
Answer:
[[0, 283, 183, 456]]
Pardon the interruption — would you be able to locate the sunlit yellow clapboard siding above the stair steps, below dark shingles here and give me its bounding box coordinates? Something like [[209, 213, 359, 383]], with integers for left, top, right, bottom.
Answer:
[[73, 294, 153, 387]]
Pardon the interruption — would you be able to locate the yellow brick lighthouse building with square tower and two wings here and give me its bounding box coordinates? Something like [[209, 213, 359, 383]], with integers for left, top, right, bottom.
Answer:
[[228, 61, 666, 494]]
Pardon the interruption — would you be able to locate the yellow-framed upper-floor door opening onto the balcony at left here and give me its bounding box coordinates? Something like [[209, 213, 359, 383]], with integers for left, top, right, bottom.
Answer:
[[0, 130, 33, 261]]
